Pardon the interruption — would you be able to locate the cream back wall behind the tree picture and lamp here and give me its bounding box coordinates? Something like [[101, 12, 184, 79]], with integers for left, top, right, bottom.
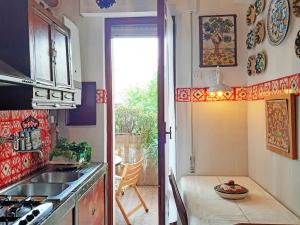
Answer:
[[171, 0, 248, 177]]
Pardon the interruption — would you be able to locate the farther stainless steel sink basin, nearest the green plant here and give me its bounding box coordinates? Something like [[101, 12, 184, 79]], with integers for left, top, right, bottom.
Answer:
[[30, 172, 84, 183]]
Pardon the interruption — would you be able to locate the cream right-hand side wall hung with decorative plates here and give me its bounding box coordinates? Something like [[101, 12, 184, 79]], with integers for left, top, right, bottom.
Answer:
[[245, 0, 300, 216]]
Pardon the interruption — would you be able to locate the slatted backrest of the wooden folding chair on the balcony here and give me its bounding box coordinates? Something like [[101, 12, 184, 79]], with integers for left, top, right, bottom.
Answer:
[[116, 159, 144, 194]]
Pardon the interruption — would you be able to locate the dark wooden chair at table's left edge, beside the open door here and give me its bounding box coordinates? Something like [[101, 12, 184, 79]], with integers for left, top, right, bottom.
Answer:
[[169, 171, 188, 225]]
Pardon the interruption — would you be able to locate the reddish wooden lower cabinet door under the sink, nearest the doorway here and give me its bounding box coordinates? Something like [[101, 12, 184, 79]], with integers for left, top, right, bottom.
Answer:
[[77, 178, 105, 225]]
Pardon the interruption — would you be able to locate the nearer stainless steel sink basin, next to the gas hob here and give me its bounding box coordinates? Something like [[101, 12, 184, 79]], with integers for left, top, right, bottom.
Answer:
[[2, 183, 69, 197]]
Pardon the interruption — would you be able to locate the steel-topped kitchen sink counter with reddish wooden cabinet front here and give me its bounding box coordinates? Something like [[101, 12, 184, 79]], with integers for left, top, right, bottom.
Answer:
[[0, 163, 107, 225]]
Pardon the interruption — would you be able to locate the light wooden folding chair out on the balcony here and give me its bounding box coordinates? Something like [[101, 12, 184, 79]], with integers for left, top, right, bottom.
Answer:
[[116, 159, 149, 225]]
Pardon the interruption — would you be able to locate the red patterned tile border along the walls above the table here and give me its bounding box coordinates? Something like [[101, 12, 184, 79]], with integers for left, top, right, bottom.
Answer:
[[176, 73, 300, 102]]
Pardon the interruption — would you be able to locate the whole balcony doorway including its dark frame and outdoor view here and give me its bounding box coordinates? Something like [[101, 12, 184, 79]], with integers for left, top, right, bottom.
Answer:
[[105, 17, 159, 225]]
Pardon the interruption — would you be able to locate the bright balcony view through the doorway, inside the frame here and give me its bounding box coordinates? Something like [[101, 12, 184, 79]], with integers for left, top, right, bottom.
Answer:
[[112, 37, 158, 225]]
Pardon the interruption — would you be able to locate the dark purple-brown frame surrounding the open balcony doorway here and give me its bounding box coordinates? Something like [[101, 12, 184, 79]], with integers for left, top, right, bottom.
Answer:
[[105, 17, 165, 225]]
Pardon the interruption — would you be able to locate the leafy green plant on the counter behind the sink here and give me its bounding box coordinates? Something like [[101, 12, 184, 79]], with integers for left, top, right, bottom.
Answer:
[[49, 138, 92, 162]]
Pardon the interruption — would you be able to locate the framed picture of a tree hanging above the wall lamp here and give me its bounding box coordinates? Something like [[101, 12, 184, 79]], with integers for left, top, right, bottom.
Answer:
[[199, 15, 237, 67]]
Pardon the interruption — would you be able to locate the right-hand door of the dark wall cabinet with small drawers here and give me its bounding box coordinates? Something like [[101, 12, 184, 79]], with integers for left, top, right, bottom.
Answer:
[[53, 25, 71, 87]]
